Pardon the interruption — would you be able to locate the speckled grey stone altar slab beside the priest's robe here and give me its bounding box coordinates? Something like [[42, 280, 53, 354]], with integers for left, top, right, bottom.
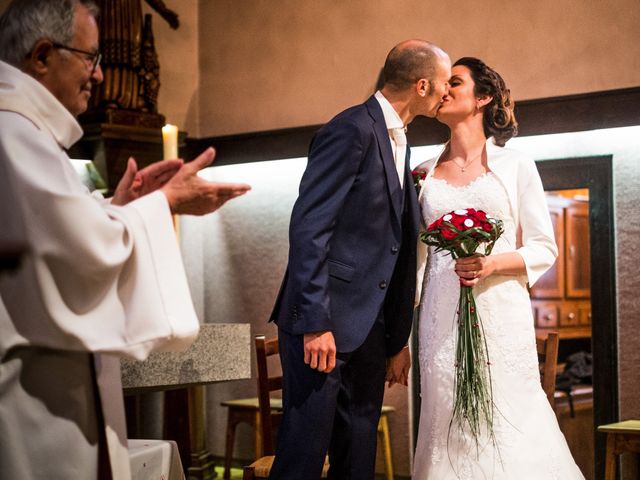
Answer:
[[121, 323, 251, 393]]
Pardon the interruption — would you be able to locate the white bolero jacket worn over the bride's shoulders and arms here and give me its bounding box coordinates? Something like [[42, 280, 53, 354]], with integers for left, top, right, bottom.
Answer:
[[416, 138, 558, 304]]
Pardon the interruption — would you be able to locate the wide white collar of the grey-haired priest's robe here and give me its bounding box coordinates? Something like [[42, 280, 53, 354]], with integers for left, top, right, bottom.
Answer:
[[0, 61, 82, 149]]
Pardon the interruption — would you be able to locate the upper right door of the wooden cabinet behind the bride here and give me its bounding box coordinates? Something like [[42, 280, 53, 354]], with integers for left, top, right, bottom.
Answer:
[[565, 202, 591, 298]]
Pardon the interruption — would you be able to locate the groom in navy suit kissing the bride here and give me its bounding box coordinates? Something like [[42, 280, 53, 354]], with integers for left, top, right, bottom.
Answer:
[[269, 40, 451, 480]]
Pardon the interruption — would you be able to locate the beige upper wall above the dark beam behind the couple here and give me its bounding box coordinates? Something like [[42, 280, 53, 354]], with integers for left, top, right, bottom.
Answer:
[[182, 0, 640, 136]]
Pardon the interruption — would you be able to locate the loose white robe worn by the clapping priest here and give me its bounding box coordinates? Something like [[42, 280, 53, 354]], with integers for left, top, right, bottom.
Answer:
[[0, 58, 199, 480]]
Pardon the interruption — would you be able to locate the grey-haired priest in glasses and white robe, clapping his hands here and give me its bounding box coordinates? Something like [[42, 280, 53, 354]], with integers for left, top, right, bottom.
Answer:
[[0, 0, 249, 480]]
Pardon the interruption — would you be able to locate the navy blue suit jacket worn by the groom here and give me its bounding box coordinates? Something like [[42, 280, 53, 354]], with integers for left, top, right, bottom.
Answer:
[[271, 97, 420, 356]]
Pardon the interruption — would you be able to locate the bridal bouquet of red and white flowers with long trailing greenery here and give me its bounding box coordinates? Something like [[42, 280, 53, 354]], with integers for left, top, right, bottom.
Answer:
[[420, 208, 504, 442]]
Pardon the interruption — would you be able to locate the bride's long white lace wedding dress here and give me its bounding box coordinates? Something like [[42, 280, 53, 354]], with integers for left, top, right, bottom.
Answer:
[[412, 173, 584, 480]]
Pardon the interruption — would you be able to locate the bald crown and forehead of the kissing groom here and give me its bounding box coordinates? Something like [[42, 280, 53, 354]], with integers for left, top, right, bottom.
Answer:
[[382, 39, 449, 91]]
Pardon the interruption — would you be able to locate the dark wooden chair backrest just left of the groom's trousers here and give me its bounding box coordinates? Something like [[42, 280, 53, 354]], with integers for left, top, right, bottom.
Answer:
[[255, 335, 282, 455]]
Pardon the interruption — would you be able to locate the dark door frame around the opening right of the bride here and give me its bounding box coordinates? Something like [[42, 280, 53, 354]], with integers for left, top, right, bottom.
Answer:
[[536, 155, 618, 478]]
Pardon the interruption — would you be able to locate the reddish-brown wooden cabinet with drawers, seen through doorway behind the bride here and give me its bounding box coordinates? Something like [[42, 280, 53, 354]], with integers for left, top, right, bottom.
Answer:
[[531, 195, 591, 338]]
